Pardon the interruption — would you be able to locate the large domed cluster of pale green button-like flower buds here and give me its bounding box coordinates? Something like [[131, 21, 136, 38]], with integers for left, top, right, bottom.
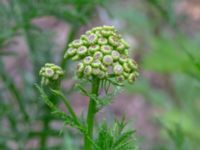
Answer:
[[64, 26, 138, 83]]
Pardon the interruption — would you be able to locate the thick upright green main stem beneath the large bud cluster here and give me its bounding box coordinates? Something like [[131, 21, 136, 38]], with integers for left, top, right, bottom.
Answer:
[[84, 77, 100, 150]]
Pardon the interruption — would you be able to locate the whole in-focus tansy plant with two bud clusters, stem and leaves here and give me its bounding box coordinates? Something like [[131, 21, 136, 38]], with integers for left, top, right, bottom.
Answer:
[[38, 26, 138, 150]]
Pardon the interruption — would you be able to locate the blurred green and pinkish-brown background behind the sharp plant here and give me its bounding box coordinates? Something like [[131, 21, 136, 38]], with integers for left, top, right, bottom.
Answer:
[[0, 0, 200, 150]]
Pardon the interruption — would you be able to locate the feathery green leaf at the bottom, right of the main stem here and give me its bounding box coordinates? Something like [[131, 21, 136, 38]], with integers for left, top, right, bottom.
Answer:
[[96, 120, 137, 150]]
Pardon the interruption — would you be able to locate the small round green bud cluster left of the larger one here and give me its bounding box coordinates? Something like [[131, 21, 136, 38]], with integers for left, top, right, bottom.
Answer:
[[39, 63, 64, 85]]
